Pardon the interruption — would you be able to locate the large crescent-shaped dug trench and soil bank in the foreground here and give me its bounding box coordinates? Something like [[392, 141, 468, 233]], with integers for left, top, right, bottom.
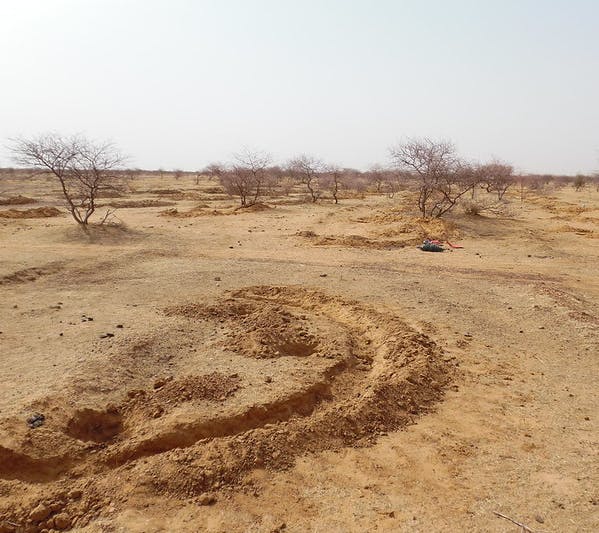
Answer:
[[0, 286, 451, 531]]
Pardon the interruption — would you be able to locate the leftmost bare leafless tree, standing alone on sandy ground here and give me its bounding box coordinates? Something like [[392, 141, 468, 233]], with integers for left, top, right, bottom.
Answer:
[[11, 134, 125, 227]]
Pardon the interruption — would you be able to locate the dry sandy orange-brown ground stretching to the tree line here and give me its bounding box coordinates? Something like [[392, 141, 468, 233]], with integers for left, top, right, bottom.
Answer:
[[0, 175, 599, 533]]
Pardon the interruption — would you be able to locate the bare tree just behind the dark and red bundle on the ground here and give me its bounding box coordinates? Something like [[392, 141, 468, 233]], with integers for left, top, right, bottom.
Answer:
[[390, 139, 477, 218]]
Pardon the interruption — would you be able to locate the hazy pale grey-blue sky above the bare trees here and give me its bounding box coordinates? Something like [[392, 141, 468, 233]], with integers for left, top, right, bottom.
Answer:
[[0, 0, 599, 173]]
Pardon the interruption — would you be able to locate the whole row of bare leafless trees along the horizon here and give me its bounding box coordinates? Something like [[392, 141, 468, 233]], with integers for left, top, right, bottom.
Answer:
[[0, 134, 599, 226]]
